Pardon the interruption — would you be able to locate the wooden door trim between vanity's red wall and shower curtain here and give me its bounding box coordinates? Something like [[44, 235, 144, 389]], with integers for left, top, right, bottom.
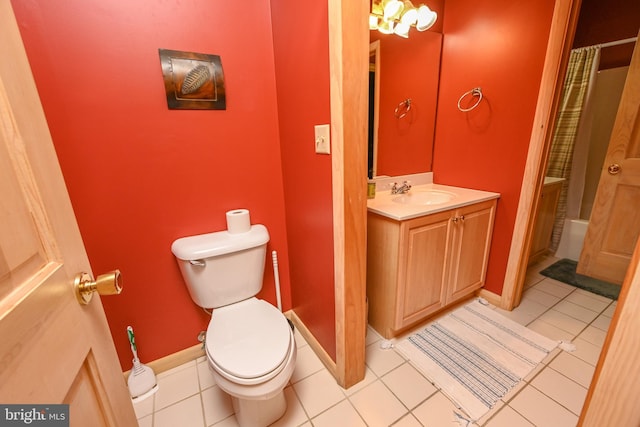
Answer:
[[500, 0, 580, 310]]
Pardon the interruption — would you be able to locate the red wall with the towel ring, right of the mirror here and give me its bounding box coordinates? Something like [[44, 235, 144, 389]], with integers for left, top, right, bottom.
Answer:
[[433, 0, 554, 294]]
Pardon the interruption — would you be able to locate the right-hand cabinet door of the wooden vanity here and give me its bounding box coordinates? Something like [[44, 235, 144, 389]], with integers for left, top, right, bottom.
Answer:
[[447, 200, 496, 303]]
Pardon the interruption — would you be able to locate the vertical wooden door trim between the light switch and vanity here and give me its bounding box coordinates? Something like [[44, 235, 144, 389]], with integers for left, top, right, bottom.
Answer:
[[328, 0, 369, 388]]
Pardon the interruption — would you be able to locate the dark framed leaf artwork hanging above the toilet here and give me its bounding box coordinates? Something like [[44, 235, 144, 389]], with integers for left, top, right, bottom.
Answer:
[[159, 49, 227, 110]]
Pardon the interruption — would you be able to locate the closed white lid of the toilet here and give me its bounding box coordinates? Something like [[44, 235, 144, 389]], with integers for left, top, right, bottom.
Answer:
[[206, 298, 291, 378]]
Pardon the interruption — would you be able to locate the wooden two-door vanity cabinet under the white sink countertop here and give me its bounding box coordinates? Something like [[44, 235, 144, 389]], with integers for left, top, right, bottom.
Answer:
[[367, 200, 496, 338]]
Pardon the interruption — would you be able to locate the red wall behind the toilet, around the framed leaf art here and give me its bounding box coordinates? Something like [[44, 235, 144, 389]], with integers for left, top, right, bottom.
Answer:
[[13, 0, 294, 369]]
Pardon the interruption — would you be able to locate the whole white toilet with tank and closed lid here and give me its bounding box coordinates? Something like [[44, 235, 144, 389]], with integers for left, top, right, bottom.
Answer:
[[171, 224, 296, 427]]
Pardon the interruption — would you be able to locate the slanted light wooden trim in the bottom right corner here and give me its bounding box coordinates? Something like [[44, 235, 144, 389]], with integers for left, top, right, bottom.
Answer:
[[578, 239, 640, 427]]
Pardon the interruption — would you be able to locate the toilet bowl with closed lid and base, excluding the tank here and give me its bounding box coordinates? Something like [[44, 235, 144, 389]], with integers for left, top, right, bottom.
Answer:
[[205, 297, 296, 427]]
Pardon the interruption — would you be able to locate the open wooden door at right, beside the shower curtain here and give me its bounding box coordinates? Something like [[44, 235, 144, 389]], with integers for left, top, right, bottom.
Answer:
[[577, 36, 640, 284]]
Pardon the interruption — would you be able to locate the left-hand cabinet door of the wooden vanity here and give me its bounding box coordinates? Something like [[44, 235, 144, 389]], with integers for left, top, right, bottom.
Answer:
[[395, 212, 451, 329]]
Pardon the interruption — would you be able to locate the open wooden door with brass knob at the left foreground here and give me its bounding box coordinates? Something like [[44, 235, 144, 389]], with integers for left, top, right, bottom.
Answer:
[[0, 0, 137, 427]]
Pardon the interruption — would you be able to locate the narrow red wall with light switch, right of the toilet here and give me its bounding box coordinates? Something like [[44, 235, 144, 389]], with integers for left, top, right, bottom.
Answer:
[[271, 0, 338, 360]]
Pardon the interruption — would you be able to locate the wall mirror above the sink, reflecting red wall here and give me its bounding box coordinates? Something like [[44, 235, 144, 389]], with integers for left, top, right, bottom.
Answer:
[[368, 15, 442, 178]]
